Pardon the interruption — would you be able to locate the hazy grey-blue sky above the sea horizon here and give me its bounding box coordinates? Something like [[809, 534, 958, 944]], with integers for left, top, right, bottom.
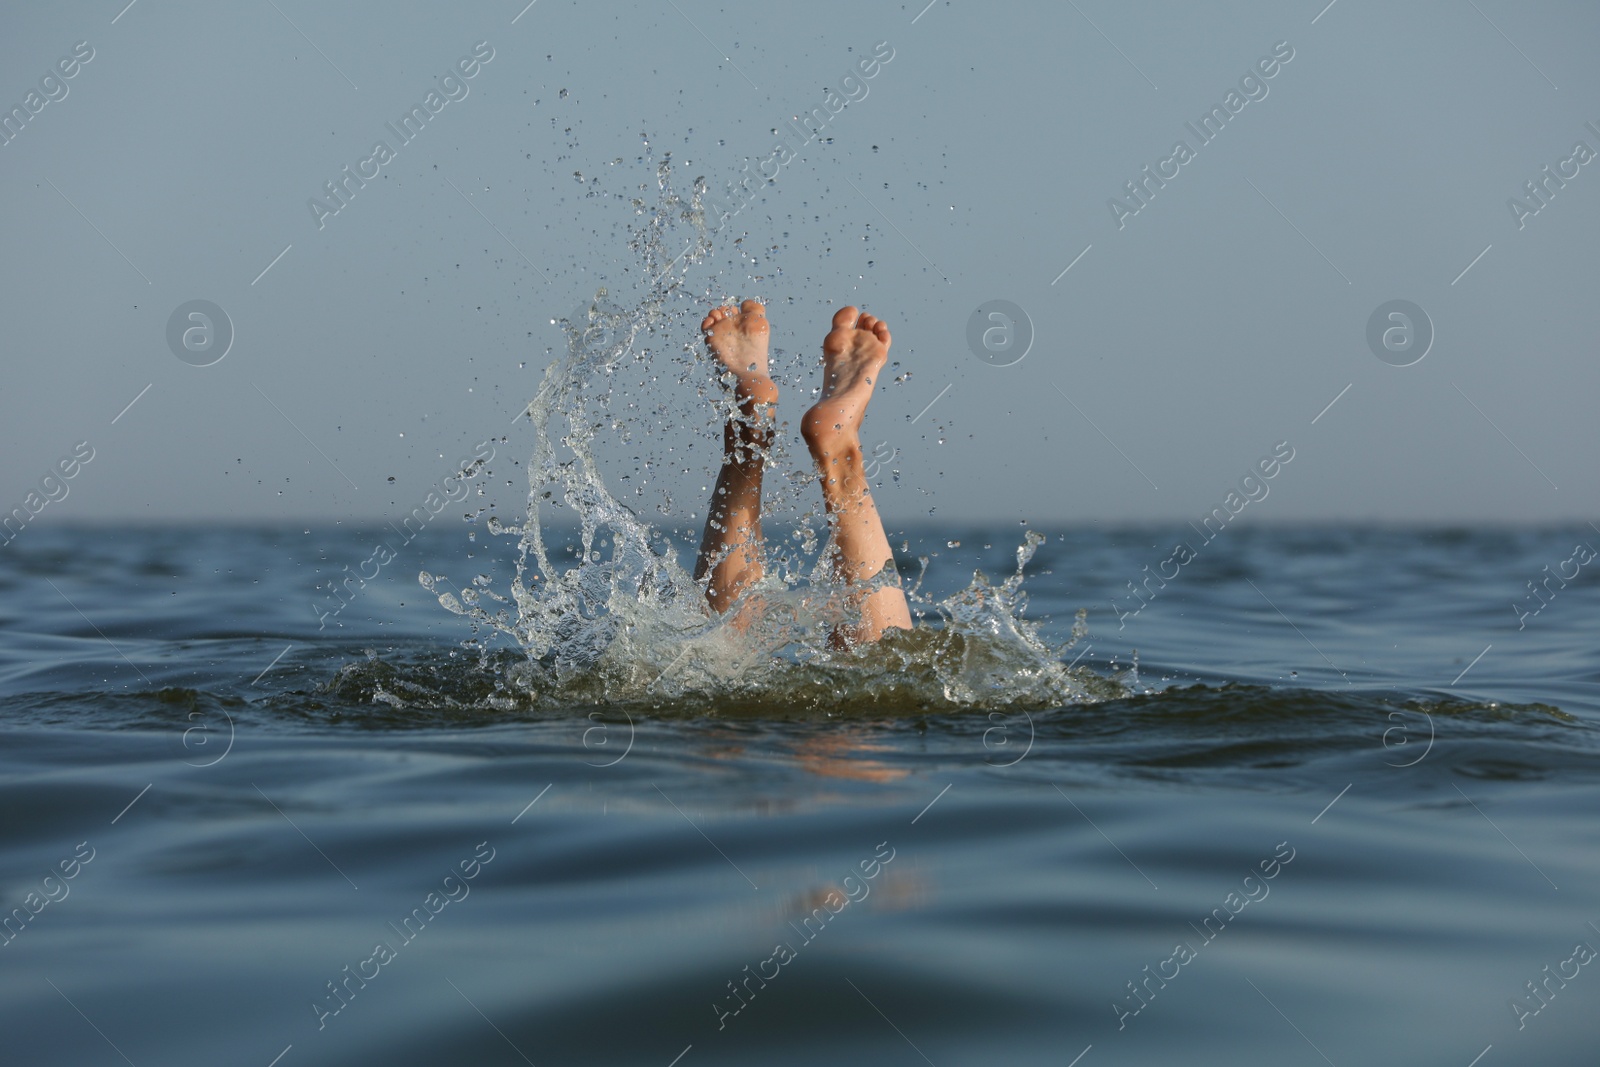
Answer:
[[0, 0, 1600, 525]]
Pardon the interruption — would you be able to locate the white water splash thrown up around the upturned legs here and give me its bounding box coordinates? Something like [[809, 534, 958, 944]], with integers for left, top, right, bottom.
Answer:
[[419, 151, 1123, 713]]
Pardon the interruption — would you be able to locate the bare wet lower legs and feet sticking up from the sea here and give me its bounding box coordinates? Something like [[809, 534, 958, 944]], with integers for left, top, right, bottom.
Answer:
[[696, 301, 910, 643]]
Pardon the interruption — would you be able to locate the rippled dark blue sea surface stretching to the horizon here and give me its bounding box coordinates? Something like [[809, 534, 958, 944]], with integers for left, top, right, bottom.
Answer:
[[0, 525, 1600, 1067]]
